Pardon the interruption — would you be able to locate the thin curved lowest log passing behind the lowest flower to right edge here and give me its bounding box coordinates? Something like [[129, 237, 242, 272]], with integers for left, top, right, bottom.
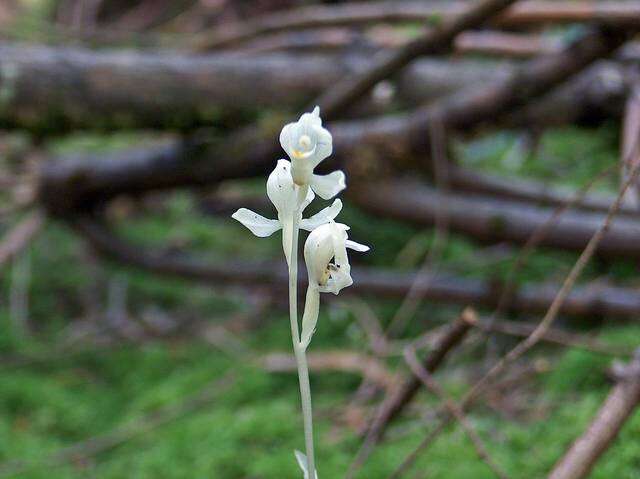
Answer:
[[69, 217, 640, 319]]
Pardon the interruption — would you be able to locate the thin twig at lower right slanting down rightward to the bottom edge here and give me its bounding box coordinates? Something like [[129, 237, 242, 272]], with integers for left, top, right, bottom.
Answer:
[[404, 347, 508, 479]]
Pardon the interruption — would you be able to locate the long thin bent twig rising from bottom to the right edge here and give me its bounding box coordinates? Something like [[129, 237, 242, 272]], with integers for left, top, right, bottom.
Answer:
[[391, 156, 640, 478]]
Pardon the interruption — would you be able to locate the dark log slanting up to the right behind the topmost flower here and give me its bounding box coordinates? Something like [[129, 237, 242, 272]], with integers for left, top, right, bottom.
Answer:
[[38, 30, 626, 213]]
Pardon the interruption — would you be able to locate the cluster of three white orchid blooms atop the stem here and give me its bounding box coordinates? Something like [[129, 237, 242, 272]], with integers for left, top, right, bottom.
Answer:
[[232, 107, 369, 294]]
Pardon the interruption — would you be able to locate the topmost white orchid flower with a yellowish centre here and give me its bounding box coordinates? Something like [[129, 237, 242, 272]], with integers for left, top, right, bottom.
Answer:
[[280, 107, 346, 200]]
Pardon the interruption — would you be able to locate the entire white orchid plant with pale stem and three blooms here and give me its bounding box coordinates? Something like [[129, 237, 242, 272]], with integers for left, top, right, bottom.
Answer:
[[232, 107, 369, 479]]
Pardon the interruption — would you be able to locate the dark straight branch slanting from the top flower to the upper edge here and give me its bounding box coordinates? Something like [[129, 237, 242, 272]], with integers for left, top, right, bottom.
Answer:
[[317, 0, 516, 119]]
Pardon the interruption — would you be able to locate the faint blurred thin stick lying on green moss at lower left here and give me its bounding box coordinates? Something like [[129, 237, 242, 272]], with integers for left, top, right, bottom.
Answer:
[[0, 374, 234, 477]]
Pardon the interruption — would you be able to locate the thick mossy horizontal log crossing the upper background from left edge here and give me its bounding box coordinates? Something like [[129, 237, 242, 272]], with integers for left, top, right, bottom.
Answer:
[[0, 39, 633, 134]]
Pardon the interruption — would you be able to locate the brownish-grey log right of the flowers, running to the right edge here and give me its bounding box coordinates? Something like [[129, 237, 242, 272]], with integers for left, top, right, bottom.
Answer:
[[349, 181, 640, 258]]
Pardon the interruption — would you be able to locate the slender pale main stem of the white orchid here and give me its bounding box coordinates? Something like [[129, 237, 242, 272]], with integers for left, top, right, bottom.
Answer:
[[289, 186, 316, 479]]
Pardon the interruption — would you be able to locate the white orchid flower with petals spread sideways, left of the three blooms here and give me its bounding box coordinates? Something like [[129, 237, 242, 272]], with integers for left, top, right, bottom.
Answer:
[[231, 160, 342, 262]]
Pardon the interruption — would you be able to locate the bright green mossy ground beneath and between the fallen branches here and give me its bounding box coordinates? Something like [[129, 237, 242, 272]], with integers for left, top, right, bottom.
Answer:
[[0, 126, 640, 479]]
